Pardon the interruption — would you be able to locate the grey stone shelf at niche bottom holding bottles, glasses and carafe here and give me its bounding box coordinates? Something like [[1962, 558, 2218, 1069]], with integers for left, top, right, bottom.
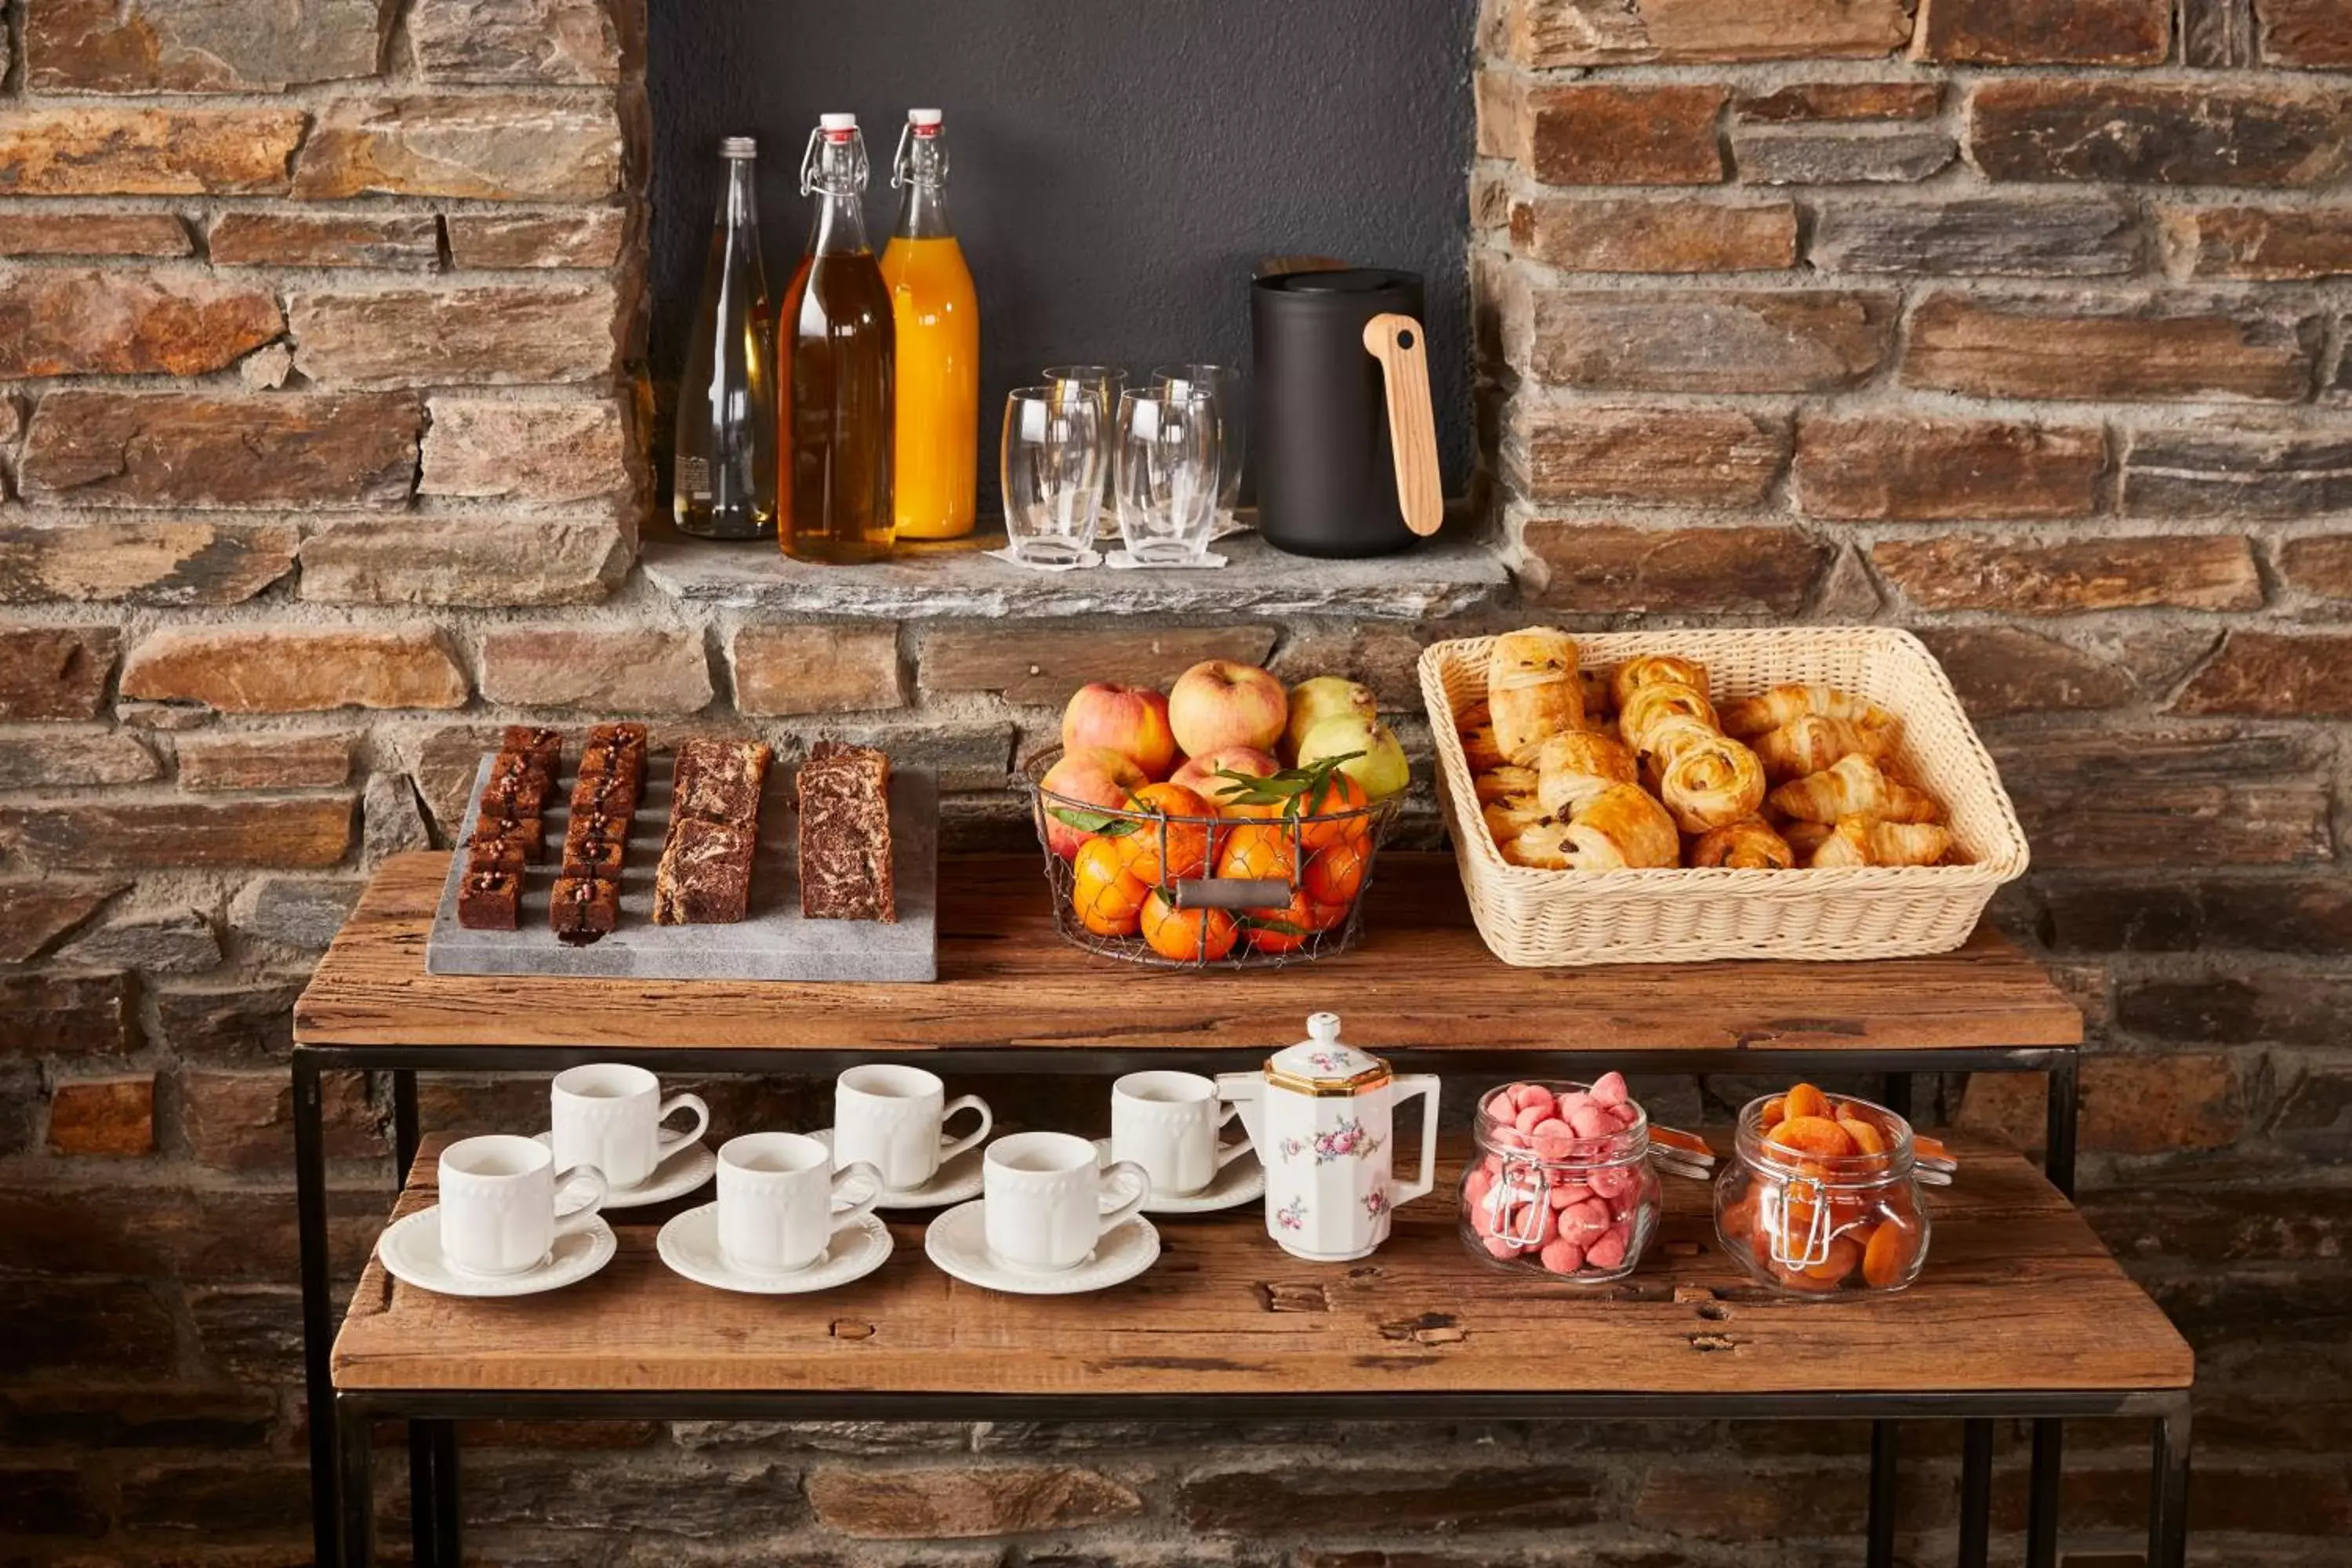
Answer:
[[640, 529, 1510, 621]]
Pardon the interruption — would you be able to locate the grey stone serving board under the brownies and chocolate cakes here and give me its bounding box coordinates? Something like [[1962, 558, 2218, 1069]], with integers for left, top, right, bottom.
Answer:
[[426, 755, 938, 982]]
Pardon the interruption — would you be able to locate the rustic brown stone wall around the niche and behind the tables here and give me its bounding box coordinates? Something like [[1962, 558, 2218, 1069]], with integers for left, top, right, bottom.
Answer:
[[0, 0, 2352, 1568]]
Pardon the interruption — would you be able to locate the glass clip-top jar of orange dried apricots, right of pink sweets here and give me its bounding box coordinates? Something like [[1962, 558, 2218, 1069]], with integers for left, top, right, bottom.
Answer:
[[1715, 1083, 1952, 1298]]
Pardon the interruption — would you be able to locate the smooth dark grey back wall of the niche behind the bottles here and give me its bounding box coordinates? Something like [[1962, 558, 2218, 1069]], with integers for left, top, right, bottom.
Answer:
[[649, 0, 1475, 513]]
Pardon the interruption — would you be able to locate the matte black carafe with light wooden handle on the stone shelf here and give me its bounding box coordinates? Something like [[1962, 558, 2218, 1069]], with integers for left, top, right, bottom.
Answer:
[[1249, 268, 1442, 557]]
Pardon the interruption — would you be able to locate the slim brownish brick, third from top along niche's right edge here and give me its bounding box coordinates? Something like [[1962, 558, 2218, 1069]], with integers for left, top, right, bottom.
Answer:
[[1510, 198, 1797, 273]]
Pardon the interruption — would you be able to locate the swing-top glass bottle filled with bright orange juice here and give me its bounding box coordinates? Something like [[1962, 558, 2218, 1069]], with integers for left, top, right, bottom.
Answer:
[[882, 108, 981, 539]]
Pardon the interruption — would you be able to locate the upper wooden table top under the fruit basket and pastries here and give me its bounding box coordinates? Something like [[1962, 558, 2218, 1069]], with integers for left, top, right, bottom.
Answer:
[[294, 853, 2082, 1051]]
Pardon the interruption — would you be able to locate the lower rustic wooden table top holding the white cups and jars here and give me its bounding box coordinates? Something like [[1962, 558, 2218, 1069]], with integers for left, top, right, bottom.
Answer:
[[334, 1142, 2194, 1394]]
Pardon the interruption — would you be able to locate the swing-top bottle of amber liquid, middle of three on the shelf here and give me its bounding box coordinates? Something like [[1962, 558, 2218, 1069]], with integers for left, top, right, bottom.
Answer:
[[776, 115, 898, 562]]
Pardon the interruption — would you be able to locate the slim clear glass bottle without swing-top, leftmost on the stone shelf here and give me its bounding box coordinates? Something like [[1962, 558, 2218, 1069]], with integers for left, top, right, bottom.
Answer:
[[670, 136, 776, 539]]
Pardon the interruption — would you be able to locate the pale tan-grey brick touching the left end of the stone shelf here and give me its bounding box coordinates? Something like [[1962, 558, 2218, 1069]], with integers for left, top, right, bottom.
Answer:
[[301, 517, 630, 604]]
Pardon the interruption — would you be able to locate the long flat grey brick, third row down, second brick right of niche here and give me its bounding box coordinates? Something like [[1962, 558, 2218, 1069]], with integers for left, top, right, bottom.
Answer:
[[1806, 198, 2145, 278]]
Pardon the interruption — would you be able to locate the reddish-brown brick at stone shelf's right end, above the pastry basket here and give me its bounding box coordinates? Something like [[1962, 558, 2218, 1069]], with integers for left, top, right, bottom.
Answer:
[[1517, 517, 1835, 616]]
